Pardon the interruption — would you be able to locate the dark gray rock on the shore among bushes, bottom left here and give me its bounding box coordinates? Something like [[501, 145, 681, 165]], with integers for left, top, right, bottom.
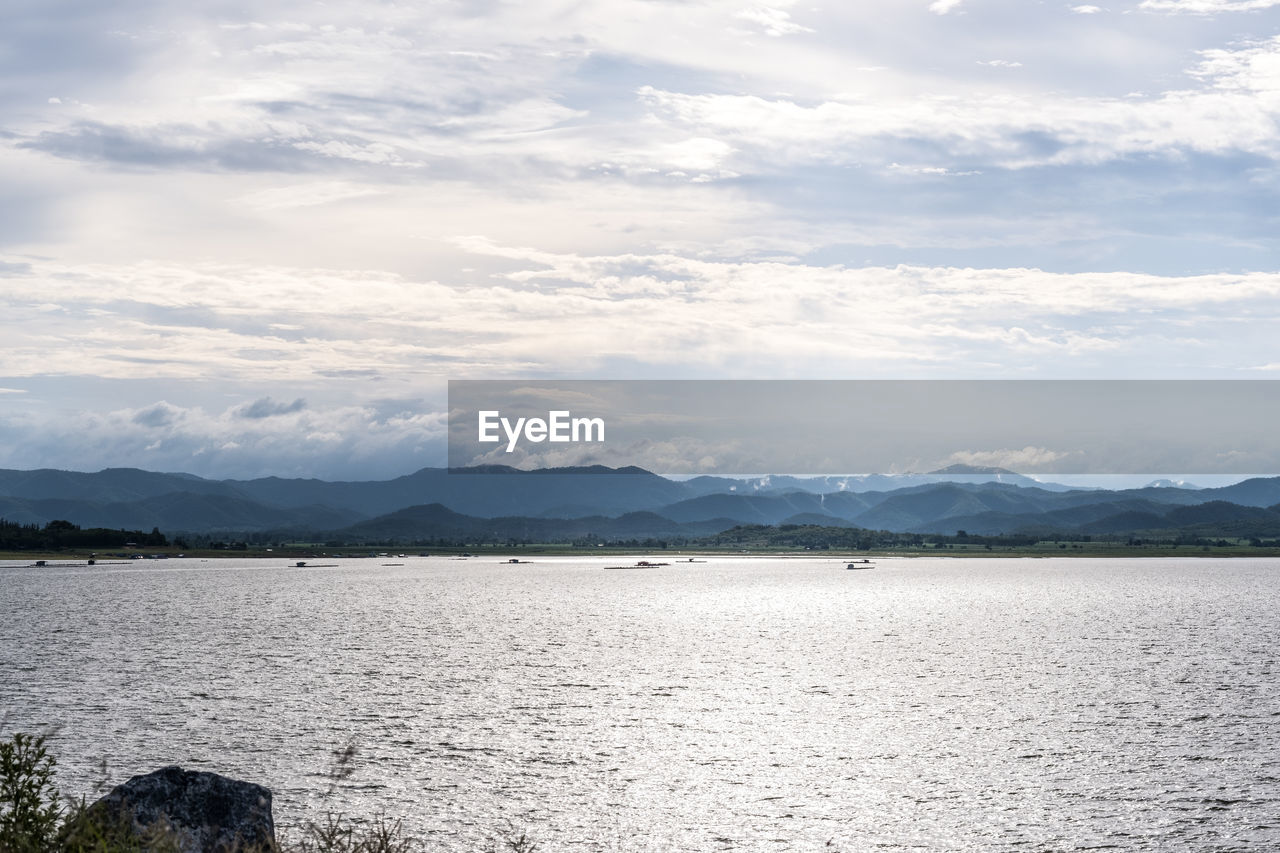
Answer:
[[90, 767, 276, 853]]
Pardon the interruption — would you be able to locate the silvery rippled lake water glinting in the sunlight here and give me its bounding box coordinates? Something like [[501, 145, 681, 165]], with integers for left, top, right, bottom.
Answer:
[[0, 557, 1280, 853]]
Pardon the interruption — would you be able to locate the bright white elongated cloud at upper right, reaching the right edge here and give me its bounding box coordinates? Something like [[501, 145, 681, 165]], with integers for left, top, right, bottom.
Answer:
[[640, 37, 1280, 173]]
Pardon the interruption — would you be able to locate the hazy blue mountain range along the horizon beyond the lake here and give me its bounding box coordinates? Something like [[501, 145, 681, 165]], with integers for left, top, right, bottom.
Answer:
[[0, 466, 1280, 540]]
